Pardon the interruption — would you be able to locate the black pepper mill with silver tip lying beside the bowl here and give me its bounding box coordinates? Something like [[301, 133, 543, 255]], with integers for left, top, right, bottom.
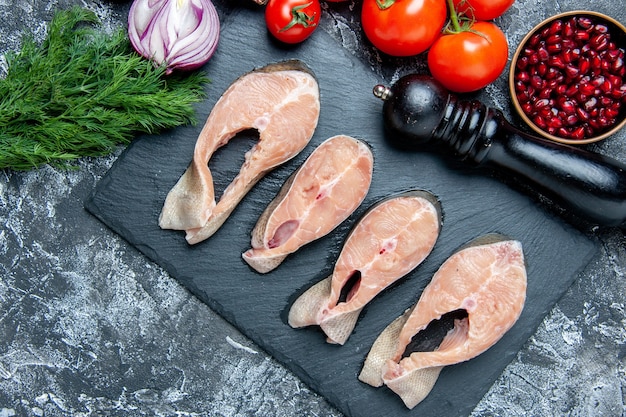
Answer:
[[374, 74, 626, 226]]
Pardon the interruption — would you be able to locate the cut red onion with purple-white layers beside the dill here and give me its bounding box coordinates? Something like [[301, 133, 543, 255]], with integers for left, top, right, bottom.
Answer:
[[128, 0, 220, 74]]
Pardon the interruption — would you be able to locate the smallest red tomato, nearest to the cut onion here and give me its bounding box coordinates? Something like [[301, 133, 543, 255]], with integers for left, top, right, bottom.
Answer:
[[265, 0, 322, 43]]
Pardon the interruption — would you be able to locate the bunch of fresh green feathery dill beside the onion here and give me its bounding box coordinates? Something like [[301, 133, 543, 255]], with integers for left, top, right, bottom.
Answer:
[[0, 6, 209, 170]]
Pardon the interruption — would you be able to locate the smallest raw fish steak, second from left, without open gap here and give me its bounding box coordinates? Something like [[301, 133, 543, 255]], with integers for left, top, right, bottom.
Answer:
[[242, 135, 374, 273]]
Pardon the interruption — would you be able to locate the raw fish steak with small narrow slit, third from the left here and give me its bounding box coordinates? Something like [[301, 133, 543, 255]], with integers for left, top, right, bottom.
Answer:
[[289, 190, 441, 345]]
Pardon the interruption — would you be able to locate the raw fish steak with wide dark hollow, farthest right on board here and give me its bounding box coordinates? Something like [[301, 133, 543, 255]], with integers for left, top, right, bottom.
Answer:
[[359, 234, 526, 408]]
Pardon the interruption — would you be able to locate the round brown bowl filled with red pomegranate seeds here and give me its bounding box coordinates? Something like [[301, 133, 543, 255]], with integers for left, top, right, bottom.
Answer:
[[509, 10, 626, 145]]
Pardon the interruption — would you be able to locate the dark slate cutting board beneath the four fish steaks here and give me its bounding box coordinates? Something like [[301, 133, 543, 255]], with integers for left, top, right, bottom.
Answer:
[[85, 6, 596, 417]]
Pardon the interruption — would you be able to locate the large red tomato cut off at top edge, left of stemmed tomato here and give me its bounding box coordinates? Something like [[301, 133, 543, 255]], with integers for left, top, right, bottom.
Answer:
[[361, 0, 448, 56]]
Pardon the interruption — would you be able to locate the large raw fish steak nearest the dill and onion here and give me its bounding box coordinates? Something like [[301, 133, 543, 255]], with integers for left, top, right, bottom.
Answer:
[[159, 60, 320, 244]]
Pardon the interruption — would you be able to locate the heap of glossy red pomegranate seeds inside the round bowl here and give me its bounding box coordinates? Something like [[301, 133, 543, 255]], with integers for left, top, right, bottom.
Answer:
[[515, 16, 626, 139]]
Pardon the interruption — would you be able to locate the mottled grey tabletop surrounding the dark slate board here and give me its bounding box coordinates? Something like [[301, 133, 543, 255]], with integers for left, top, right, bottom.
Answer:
[[0, 0, 626, 417]]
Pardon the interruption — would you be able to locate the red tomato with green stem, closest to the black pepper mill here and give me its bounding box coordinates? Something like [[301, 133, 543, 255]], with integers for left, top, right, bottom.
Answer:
[[428, 22, 509, 93]]
